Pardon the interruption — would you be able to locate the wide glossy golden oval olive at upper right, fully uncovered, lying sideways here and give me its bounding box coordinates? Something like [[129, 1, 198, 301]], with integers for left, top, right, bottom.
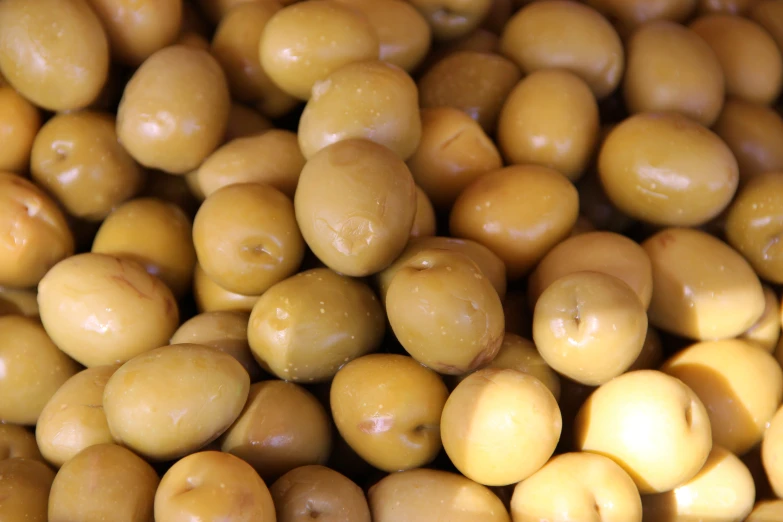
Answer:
[[598, 113, 739, 226]]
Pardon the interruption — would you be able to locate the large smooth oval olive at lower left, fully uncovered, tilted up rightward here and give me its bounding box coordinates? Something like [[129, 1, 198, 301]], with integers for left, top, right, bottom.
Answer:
[[103, 344, 250, 460]]
